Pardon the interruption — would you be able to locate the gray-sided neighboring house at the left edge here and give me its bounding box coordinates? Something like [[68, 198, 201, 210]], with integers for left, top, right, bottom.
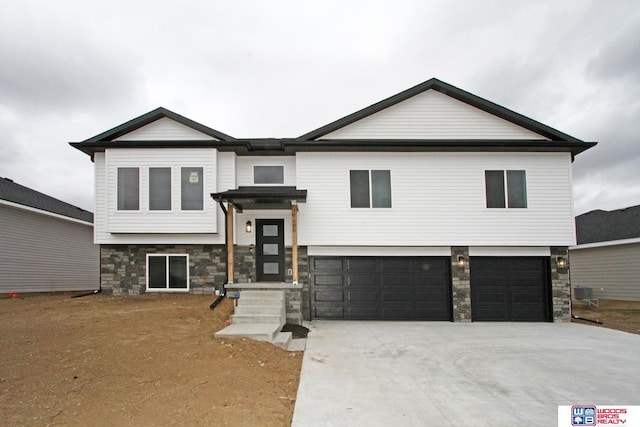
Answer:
[[0, 178, 100, 293]]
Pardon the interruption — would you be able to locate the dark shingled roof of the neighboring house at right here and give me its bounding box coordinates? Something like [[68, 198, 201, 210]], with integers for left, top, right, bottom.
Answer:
[[576, 205, 640, 245]]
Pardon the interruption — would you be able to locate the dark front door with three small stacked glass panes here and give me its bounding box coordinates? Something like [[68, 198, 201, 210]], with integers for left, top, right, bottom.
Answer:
[[256, 219, 284, 282]]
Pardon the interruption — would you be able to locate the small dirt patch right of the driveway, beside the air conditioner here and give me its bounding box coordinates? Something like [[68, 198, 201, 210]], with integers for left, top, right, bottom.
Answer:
[[572, 300, 640, 334]]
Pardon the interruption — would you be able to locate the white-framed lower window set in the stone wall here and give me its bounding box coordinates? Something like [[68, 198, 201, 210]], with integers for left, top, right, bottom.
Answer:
[[147, 254, 189, 291]]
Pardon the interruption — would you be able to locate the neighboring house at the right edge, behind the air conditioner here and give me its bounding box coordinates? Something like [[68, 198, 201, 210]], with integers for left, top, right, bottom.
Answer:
[[569, 206, 640, 301]]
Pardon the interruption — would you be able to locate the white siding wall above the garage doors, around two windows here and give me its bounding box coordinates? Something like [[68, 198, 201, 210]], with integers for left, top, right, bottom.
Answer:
[[297, 153, 575, 246]]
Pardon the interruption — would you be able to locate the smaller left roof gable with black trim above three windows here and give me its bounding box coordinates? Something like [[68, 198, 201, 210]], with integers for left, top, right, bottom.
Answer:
[[84, 107, 234, 142]]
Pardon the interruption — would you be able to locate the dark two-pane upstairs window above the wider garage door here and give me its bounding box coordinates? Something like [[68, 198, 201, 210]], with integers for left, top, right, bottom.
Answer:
[[349, 170, 391, 208]]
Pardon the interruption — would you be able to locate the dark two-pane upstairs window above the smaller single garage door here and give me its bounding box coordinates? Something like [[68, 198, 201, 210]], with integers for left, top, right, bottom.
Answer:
[[484, 170, 527, 208]]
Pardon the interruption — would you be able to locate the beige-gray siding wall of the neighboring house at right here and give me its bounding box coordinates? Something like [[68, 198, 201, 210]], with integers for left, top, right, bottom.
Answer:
[[569, 243, 640, 301]]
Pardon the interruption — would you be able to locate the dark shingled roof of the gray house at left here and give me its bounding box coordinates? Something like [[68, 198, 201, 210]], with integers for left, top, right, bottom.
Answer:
[[0, 177, 93, 223]]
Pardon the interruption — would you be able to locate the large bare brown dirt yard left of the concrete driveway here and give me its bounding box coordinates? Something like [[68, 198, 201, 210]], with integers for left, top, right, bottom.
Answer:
[[0, 295, 302, 426]]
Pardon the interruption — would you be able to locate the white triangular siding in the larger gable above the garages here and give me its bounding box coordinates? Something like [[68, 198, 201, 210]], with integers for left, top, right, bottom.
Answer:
[[321, 90, 548, 140]]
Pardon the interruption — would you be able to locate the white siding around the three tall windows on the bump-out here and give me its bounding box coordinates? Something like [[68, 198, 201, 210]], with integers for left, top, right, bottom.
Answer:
[[105, 148, 218, 233]]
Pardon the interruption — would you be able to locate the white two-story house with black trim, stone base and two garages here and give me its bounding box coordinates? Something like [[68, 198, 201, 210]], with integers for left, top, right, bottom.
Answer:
[[71, 79, 595, 321]]
